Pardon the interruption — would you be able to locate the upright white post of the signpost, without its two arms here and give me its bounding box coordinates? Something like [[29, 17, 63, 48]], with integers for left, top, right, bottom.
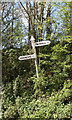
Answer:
[[30, 36, 39, 78]]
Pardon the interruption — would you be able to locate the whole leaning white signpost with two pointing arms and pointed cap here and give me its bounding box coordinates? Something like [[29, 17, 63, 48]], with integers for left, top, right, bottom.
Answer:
[[18, 36, 50, 78]]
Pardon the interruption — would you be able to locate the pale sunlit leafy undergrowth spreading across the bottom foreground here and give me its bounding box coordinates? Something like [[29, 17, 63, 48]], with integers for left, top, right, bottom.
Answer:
[[4, 80, 72, 119]]
